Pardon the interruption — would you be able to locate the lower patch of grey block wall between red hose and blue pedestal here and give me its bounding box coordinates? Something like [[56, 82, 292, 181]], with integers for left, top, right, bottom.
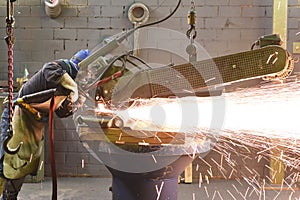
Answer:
[[45, 117, 110, 177]]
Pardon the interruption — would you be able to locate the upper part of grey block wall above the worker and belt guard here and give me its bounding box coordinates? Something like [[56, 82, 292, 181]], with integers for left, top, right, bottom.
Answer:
[[0, 0, 274, 79]]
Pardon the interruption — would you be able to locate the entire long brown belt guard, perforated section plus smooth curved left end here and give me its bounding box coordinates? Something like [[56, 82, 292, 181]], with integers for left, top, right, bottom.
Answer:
[[113, 46, 289, 102]]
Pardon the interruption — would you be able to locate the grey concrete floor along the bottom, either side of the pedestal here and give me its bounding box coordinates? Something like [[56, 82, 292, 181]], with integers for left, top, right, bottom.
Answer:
[[19, 177, 300, 200]]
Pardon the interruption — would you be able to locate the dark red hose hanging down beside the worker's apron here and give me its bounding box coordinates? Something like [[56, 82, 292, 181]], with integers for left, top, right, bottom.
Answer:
[[48, 96, 57, 200]]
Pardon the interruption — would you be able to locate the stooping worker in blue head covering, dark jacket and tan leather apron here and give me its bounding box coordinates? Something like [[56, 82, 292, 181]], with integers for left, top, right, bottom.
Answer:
[[0, 50, 90, 200]]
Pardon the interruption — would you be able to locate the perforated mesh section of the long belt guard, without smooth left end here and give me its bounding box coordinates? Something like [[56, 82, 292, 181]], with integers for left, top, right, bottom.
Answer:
[[147, 46, 287, 96]]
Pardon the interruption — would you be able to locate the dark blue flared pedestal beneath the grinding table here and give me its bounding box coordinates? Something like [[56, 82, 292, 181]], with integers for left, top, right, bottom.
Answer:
[[107, 155, 193, 200]]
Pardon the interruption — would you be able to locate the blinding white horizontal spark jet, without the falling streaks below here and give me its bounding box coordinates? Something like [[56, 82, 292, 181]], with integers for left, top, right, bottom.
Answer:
[[116, 78, 300, 139]]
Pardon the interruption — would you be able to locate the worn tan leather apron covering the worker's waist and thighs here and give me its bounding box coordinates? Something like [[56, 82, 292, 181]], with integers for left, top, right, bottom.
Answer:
[[3, 106, 45, 179]]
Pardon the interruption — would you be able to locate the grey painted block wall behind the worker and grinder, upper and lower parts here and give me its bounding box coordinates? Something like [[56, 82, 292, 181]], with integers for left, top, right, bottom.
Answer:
[[0, 0, 300, 176]]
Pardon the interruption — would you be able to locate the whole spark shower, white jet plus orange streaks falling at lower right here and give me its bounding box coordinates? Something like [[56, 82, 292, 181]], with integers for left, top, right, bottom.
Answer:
[[115, 77, 300, 199]]
